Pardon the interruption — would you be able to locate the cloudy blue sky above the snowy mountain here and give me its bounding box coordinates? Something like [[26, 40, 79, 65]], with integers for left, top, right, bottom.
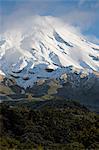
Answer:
[[0, 0, 99, 43]]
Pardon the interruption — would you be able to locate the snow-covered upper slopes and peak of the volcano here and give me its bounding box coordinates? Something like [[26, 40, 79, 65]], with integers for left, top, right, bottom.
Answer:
[[0, 17, 99, 87]]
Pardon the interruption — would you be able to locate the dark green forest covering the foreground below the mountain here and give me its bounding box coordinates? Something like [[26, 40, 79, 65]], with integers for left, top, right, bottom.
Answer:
[[0, 100, 99, 150]]
